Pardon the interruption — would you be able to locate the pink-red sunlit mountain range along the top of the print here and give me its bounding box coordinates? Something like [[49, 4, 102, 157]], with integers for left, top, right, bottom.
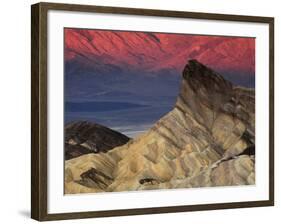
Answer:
[[65, 28, 255, 78]]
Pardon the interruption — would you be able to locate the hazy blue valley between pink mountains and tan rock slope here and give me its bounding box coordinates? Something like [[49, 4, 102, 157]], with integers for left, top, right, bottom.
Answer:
[[65, 71, 180, 137]]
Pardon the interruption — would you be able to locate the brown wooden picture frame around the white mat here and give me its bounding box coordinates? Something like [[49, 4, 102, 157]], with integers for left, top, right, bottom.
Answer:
[[31, 3, 274, 221]]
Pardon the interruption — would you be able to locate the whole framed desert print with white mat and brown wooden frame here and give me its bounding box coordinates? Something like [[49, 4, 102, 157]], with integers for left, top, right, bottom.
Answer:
[[31, 3, 274, 221]]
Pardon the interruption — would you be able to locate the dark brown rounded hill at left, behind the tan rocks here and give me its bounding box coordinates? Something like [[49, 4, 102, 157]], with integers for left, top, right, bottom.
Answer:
[[64, 121, 130, 160]]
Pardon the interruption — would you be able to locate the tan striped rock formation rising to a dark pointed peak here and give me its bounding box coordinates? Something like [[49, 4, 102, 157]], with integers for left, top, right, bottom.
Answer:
[[65, 60, 255, 194]]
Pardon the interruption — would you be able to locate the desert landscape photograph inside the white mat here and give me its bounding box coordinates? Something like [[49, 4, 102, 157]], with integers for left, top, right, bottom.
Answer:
[[62, 27, 256, 194]]
